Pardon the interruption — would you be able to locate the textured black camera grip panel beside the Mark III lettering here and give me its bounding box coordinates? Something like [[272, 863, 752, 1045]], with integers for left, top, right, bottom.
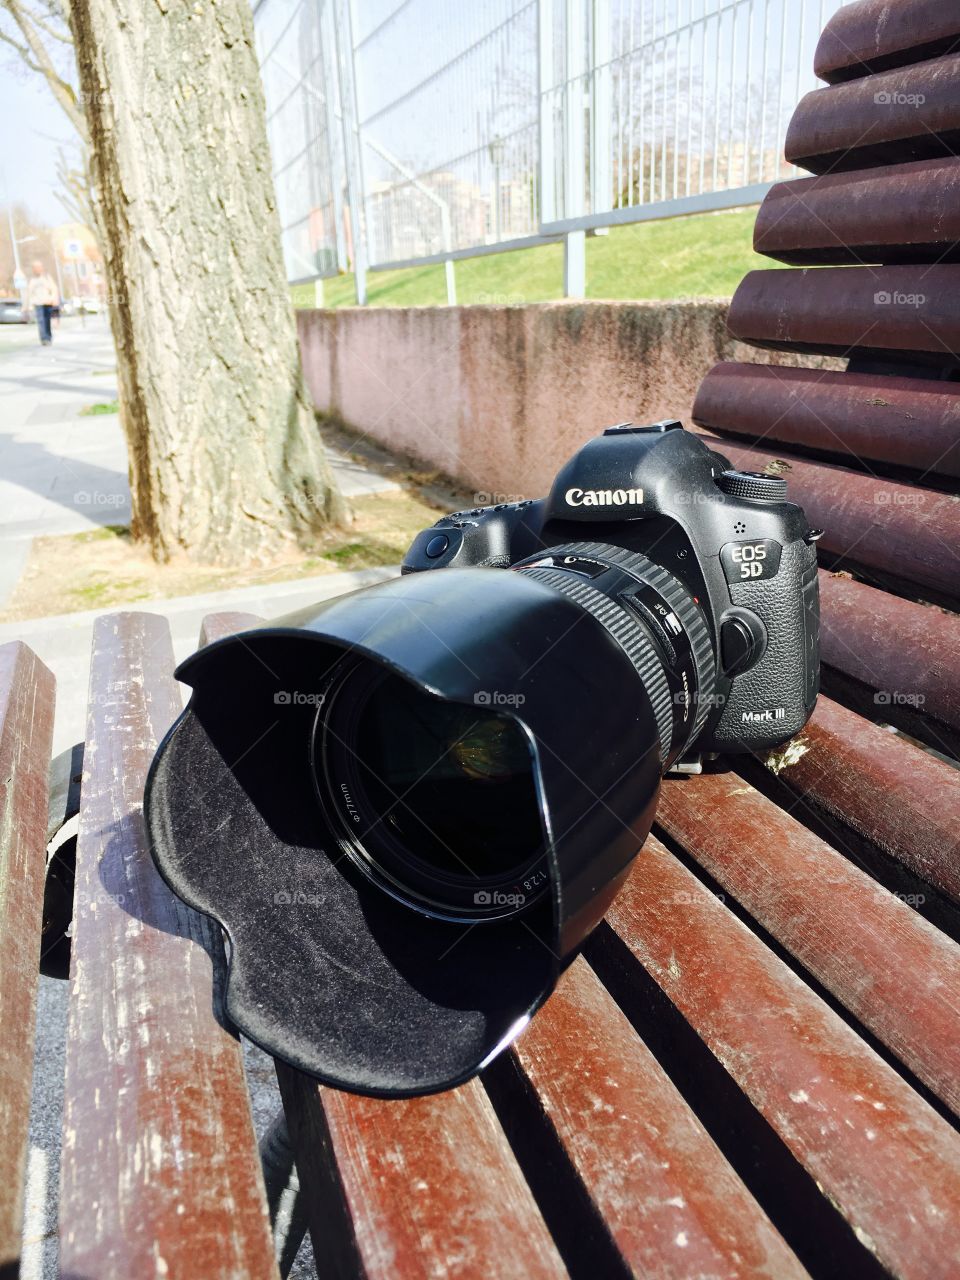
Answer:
[[713, 541, 820, 751]]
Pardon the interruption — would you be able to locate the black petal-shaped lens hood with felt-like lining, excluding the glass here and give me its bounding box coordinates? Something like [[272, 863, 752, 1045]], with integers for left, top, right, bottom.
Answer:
[[145, 568, 660, 1097]]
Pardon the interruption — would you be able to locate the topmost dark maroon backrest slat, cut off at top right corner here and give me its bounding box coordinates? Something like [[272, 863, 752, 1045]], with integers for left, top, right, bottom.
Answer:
[[813, 0, 960, 84]]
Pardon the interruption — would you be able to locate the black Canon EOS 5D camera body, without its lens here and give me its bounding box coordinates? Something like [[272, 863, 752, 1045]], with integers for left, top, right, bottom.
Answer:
[[403, 420, 819, 768]]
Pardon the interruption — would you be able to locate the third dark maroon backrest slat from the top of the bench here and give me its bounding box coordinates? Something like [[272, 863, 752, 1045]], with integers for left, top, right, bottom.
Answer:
[[754, 156, 960, 266]]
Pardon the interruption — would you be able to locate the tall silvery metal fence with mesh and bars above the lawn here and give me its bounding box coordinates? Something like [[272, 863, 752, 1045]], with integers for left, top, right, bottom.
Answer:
[[255, 0, 842, 302]]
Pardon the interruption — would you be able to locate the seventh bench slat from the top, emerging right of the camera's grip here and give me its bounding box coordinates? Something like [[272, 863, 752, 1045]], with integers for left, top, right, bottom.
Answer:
[[820, 568, 960, 755]]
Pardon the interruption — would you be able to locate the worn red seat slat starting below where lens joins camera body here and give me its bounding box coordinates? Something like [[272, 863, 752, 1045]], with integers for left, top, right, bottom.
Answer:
[[657, 773, 960, 1112]]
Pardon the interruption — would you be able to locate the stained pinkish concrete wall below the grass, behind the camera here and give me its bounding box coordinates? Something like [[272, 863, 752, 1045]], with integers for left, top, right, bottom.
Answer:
[[297, 302, 834, 500]]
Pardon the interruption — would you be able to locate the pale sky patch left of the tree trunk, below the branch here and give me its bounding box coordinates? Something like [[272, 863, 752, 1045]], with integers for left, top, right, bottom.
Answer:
[[0, 46, 77, 225]]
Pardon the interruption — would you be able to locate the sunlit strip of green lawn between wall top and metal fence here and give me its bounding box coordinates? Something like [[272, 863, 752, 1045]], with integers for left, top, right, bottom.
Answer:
[[292, 206, 777, 307]]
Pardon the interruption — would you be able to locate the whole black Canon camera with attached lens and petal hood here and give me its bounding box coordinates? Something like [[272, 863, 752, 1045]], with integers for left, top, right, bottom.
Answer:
[[145, 420, 819, 1096]]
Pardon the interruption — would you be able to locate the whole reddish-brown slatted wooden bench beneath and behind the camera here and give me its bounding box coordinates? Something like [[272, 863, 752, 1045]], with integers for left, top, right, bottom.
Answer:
[[0, 0, 960, 1280]]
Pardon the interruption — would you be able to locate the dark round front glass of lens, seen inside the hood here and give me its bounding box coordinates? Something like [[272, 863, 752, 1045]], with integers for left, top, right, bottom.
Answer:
[[312, 659, 547, 920]]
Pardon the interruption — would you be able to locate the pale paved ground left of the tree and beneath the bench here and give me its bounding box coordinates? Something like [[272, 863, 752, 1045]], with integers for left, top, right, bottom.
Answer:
[[0, 316, 397, 1280]]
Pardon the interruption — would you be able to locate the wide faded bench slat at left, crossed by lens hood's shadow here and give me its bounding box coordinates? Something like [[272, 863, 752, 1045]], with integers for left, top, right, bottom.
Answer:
[[60, 613, 276, 1280]]
